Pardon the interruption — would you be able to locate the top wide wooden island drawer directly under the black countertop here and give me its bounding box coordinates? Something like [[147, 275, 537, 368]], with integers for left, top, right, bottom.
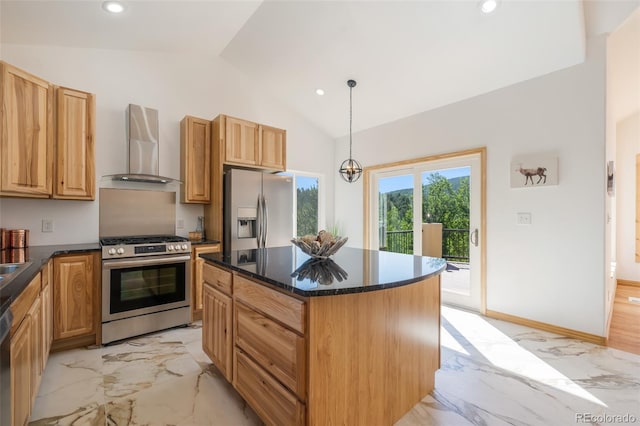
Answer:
[[233, 275, 305, 334]]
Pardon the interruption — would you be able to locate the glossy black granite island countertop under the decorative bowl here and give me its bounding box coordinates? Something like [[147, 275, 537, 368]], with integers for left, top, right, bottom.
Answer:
[[200, 245, 446, 297]]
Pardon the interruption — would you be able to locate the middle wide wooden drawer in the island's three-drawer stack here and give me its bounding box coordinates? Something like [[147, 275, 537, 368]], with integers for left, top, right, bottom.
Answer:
[[234, 303, 306, 401]]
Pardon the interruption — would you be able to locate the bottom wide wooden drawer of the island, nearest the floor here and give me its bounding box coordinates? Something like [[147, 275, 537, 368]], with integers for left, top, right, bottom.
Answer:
[[233, 350, 305, 426]]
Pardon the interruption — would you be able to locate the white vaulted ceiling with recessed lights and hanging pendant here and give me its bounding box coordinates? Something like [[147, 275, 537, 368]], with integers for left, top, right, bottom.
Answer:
[[0, 0, 639, 137]]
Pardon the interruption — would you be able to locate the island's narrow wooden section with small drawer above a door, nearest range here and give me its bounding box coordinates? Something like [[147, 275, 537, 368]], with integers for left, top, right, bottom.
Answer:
[[202, 263, 233, 381]]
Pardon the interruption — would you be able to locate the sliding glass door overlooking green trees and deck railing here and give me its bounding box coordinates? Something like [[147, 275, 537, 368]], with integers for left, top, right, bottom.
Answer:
[[368, 152, 483, 311]]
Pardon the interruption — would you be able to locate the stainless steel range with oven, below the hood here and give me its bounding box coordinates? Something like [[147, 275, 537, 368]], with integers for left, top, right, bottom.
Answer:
[[100, 235, 191, 344]]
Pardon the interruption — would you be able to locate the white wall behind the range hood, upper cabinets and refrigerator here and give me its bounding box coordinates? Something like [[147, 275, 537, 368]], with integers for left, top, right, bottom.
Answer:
[[0, 44, 334, 245]]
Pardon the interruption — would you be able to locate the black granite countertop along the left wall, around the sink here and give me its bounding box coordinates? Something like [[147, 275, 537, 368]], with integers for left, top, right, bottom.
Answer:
[[0, 242, 100, 315]]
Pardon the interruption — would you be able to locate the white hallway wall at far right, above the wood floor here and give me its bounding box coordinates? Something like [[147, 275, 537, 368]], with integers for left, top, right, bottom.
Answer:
[[607, 8, 640, 281]]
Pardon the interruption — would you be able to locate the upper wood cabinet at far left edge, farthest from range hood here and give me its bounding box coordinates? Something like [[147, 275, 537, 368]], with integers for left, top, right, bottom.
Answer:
[[0, 62, 53, 198]]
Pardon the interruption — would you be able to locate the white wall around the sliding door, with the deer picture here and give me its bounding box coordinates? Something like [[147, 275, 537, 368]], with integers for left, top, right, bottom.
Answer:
[[335, 37, 606, 336]]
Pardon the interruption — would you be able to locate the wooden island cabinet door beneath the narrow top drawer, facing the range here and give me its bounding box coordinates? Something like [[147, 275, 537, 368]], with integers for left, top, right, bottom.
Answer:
[[202, 284, 233, 381]]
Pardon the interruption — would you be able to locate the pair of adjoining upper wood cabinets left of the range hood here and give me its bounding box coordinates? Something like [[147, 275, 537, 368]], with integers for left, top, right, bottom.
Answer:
[[0, 62, 96, 200]]
